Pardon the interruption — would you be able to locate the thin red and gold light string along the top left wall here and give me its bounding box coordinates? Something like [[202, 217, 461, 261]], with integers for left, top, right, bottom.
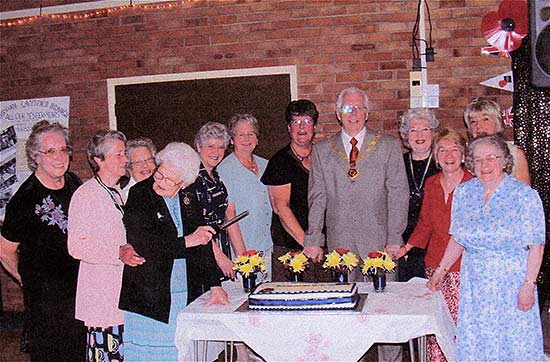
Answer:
[[0, 0, 191, 28]]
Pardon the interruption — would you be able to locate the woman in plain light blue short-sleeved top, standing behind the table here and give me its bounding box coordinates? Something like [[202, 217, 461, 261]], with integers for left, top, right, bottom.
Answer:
[[217, 114, 273, 280]]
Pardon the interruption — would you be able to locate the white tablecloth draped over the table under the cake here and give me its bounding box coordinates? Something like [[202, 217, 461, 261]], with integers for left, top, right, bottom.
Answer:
[[176, 279, 456, 361]]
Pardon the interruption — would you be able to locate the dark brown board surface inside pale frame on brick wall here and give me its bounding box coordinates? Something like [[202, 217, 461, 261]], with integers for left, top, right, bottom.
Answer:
[[115, 74, 291, 158]]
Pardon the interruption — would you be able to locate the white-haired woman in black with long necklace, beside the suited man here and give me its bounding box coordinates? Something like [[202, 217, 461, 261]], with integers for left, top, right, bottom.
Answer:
[[398, 108, 439, 282]]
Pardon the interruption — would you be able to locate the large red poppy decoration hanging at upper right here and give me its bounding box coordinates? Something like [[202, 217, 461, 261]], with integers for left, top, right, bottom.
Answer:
[[481, 0, 529, 53]]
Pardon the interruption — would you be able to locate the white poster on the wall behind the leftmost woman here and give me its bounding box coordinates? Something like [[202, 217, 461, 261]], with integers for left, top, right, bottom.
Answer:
[[0, 97, 69, 220]]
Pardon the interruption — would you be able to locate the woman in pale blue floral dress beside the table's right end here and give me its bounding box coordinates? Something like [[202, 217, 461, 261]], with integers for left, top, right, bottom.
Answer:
[[428, 136, 545, 361]]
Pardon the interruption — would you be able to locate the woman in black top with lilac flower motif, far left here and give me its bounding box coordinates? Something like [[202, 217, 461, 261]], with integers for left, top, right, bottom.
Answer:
[[0, 121, 86, 362]]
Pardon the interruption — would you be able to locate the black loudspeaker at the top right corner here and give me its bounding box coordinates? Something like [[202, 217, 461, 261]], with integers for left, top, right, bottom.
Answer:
[[529, 0, 550, 87]]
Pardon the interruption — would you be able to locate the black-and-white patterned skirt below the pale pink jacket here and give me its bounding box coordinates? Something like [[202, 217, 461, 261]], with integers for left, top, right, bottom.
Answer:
[[86, 324, 124, 362]]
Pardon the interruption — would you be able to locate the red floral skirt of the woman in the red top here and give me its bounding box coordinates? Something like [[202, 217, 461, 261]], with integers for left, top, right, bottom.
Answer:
[[426, 266, 460, 362]]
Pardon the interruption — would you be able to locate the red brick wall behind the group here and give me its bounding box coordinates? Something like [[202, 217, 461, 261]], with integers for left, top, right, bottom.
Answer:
[[0, 0, 512, 177]]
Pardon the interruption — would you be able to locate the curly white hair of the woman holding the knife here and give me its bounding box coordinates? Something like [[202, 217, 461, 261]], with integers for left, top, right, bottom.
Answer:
[[155, 142, 201, 187]]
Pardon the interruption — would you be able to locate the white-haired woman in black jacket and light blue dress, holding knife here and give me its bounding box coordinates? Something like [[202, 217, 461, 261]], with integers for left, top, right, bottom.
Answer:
[[119, 142, 228, 361]]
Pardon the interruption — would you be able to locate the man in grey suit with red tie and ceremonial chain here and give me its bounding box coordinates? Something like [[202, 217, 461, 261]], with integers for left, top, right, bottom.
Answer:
[[304, 87, 409, 361]]
